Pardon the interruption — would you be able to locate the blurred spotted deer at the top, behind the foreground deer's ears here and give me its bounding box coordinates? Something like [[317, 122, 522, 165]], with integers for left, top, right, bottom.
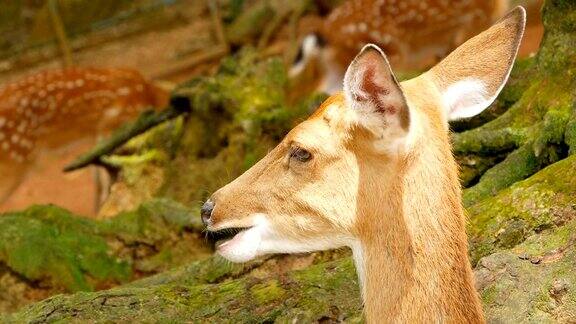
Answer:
[[291, 0, 509, 93]]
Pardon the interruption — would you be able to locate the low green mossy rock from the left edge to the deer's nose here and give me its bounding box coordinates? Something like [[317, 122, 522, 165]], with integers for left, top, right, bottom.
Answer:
[[0, 199, 211, 311]]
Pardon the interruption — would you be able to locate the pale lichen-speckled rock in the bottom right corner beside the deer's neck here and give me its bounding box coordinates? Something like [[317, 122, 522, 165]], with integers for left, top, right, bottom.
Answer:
[[476, 221, 576, 323]]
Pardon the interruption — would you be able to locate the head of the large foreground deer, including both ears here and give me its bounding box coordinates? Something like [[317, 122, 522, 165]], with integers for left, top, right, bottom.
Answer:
[[204, 5, 524, 260]]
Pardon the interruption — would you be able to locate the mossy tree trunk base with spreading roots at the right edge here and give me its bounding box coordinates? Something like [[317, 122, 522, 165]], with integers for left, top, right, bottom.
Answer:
[[453, 0, 576, 207]]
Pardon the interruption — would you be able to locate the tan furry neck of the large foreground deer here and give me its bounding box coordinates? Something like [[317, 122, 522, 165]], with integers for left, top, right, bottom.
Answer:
[[353, 138, 483, 323]]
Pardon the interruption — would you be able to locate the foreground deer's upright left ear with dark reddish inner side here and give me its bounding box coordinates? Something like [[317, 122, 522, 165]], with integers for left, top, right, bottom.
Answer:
[[344, 44, 410, 132]]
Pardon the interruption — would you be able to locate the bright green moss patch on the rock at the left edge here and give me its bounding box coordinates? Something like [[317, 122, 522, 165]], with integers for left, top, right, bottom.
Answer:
[[0, 206, 131, 291]]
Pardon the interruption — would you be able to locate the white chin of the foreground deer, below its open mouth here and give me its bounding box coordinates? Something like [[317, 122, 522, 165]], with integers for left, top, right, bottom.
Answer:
[[217, 227, 262, 263]]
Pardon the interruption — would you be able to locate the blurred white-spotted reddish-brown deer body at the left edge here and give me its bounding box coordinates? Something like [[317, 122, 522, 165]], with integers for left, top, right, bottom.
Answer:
[[0, 68, 168, 202]]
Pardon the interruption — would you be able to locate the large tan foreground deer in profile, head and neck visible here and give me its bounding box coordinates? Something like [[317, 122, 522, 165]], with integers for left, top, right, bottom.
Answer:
[[201, 7, 526, 323]]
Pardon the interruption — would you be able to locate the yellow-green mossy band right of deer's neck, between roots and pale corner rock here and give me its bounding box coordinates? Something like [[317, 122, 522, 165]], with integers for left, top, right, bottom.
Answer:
[[468, 157, 576, 263]]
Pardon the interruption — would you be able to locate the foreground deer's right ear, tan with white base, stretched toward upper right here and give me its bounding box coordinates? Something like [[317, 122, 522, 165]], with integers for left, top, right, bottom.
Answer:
[[427, 7, 526, 120]]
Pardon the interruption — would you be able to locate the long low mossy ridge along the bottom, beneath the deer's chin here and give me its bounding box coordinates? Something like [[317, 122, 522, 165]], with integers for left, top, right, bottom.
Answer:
[[5, 258, 362, 323]]
